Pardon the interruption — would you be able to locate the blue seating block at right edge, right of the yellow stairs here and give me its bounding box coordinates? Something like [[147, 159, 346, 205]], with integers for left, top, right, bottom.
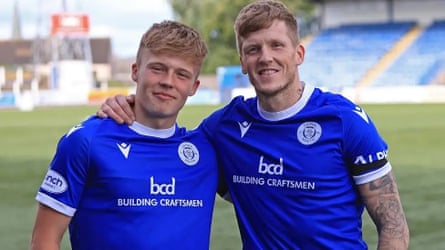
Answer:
[[373, 20, 445, 86]]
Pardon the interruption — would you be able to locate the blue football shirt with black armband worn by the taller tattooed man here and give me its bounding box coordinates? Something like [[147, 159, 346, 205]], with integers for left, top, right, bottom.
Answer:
[[200, 84, 391, 249]]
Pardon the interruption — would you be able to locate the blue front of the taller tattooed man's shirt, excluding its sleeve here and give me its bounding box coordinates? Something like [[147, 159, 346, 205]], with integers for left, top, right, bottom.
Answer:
[[201, 94, 374, 249]]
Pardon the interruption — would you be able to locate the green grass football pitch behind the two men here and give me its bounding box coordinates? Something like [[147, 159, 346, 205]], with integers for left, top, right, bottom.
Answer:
[[0, 104, 445, 250]]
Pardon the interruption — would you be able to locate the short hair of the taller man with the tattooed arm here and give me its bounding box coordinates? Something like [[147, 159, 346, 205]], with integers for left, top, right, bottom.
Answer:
[[234, 0, 300, 54]]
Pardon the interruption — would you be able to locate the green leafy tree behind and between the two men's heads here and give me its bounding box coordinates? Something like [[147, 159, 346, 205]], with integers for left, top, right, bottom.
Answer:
[[168, 0, 314, 74]]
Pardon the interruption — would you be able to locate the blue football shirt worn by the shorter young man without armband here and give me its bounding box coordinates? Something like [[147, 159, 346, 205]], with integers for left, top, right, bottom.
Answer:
[[36, 118, 218, 250]]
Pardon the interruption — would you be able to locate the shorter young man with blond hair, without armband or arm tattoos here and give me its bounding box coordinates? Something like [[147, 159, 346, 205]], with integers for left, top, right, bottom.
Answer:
[[31, 21, 218, 250]]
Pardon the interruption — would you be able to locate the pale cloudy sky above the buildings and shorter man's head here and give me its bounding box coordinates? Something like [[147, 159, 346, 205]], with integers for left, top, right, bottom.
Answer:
[[0, 0, 173, 57]]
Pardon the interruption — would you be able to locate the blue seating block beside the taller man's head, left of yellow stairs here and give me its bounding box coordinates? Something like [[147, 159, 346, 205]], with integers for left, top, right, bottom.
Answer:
[[300, 21, 415, 91]]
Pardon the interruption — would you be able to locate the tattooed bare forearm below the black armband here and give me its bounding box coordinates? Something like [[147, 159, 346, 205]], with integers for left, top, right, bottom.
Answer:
[[359, 172, 409, 250]]
